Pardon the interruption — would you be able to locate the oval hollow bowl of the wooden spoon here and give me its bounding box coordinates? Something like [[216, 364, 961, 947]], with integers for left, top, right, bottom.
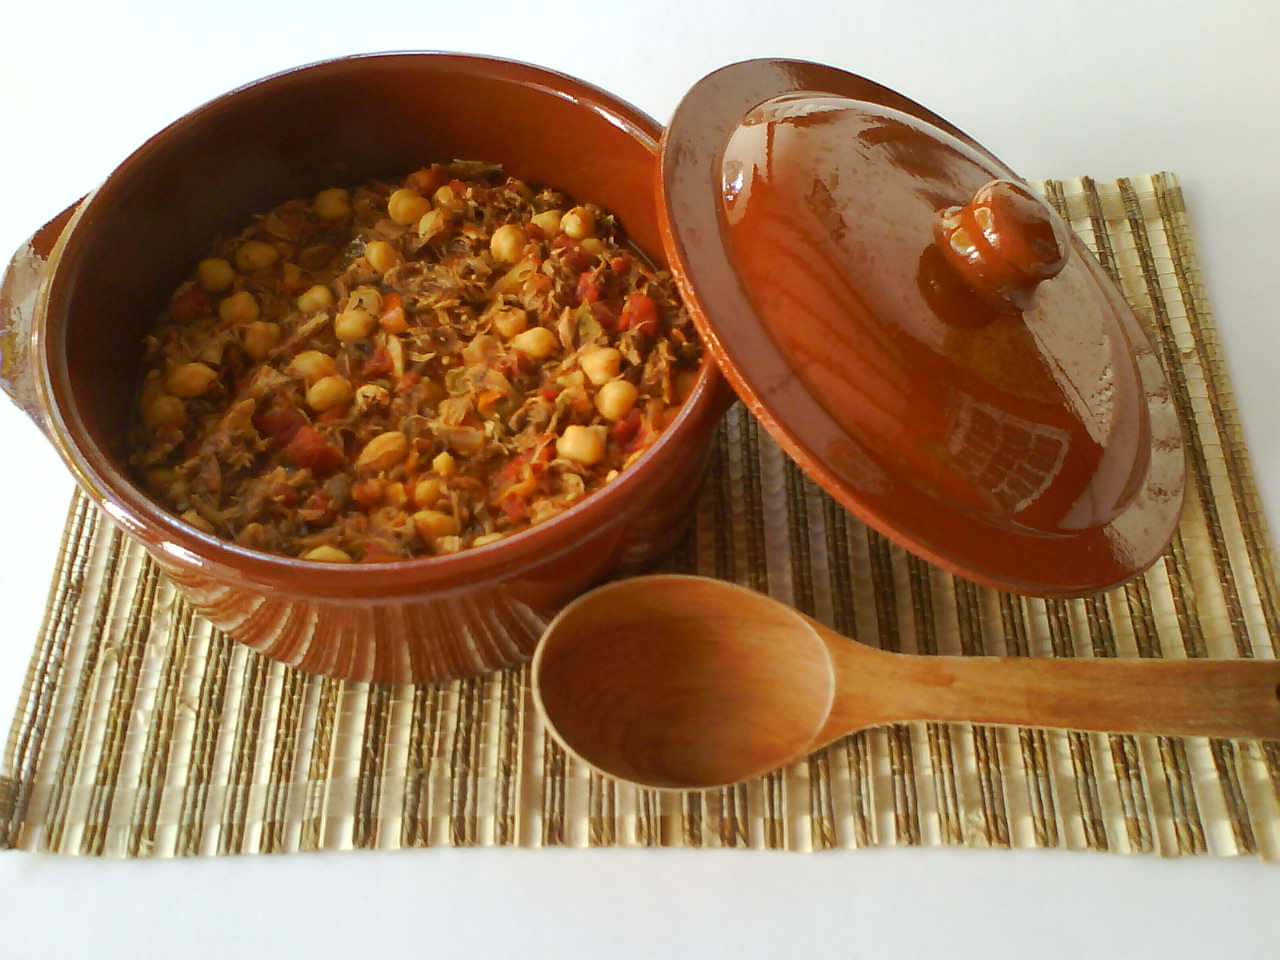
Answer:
[[534, 577, 836, 788]]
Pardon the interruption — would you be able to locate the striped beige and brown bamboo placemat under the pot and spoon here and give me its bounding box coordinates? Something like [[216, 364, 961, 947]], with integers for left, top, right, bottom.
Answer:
[[0, 174, 1280, 860]]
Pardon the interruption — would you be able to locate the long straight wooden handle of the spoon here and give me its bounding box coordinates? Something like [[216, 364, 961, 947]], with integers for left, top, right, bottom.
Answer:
[[834, 654, 1280, 739]]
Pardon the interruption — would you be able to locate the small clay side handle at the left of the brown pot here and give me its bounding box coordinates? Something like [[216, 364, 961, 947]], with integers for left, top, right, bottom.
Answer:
[[0, 201, 79, 434]]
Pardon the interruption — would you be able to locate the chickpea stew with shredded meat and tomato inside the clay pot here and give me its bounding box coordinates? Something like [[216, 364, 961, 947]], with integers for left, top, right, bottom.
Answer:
[[129, 161, 700, 563]]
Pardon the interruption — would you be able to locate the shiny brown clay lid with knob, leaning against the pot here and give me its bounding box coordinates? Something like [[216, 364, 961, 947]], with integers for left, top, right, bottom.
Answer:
[[659, 60, 1185, 595]]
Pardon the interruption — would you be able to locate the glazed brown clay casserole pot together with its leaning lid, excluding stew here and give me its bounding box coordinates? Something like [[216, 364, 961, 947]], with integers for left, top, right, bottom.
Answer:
[[0, 54, 1185, 682]]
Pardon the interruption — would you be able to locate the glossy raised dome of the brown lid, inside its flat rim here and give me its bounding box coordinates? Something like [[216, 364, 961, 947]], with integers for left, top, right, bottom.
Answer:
[[722, 96, 1147, 542]]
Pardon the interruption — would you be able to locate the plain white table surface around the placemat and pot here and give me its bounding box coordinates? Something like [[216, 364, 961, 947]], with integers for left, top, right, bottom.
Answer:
[[0, 0, 1280, 960]]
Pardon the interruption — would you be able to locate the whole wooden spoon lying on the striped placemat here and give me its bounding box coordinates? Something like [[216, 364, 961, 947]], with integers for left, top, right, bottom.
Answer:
[[532, 576, 1280, 790]]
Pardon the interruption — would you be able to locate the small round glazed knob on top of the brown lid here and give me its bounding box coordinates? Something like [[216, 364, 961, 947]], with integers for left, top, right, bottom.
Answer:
[[933, 179, 1070, 312]]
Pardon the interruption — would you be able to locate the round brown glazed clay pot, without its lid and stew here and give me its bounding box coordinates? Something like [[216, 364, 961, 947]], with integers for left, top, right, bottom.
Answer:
[[0, 54, 732, 684]]
